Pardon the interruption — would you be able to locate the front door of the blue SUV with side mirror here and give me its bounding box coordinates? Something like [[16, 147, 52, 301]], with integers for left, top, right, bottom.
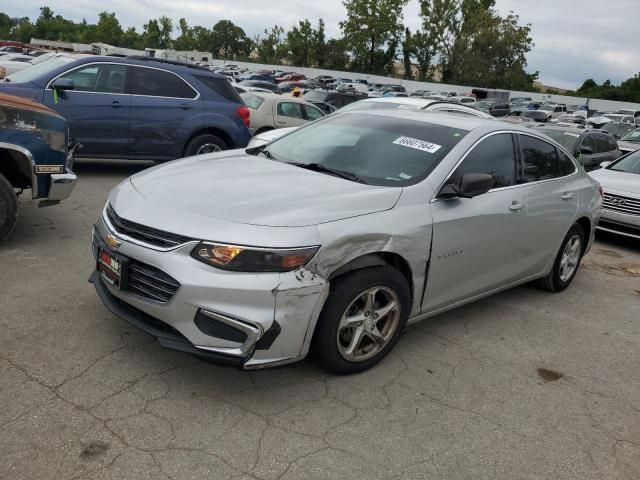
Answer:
[[43, 63, 131, 157]]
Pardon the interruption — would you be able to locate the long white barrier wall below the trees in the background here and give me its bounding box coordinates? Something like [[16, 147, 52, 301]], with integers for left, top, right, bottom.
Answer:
[[212, 60, 640, 111]]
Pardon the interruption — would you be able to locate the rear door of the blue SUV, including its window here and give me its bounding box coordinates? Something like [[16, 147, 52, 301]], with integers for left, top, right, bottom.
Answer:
[[128, 66, 204, 159]]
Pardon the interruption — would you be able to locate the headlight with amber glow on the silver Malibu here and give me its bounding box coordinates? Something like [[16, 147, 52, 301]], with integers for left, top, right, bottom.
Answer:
[[191, 242, 319, 272]]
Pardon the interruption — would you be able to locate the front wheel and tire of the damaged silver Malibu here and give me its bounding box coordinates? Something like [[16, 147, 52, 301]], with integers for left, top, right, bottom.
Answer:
[[312, 266, 411, 375]]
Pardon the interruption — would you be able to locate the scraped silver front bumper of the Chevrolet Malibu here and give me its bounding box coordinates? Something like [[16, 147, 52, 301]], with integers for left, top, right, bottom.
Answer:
[[89, 217, 328, 369]]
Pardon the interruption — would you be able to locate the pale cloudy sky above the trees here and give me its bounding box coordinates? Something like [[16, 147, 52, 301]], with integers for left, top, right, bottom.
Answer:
[[6, 0, 640, 88]]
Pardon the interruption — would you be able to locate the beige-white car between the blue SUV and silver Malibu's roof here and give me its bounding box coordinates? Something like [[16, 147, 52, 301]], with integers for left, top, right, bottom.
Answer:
[[240, 92, 324, 134]]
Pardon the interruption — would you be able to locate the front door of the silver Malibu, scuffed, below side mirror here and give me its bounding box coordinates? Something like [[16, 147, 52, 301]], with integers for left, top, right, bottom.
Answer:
[[423, 133, 525, 312]]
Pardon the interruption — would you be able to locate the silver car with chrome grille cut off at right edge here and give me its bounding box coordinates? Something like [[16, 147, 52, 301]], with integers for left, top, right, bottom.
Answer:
[[589, 150, 640, 239]]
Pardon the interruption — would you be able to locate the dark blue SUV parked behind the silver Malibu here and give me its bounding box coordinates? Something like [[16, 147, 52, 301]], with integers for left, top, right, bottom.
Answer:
[[0, 56, 251, 160]]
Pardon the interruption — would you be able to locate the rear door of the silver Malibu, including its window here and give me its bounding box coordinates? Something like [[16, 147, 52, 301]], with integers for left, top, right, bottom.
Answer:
[[516, 134, 580, 278]]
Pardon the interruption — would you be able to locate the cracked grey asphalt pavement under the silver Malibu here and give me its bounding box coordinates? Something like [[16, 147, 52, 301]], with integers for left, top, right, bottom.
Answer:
[[0, 161, 640, 480]]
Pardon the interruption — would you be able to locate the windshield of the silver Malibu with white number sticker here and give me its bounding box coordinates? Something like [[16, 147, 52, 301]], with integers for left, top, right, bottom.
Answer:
[[258, 112, 468, 187]]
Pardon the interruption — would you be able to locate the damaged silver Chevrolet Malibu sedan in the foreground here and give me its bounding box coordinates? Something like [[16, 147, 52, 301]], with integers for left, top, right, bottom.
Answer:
[[90, 109, 602, 374]]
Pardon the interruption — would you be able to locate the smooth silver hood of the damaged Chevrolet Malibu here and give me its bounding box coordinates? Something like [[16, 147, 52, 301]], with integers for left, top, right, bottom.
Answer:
[[131, 150, 402, 227]]
